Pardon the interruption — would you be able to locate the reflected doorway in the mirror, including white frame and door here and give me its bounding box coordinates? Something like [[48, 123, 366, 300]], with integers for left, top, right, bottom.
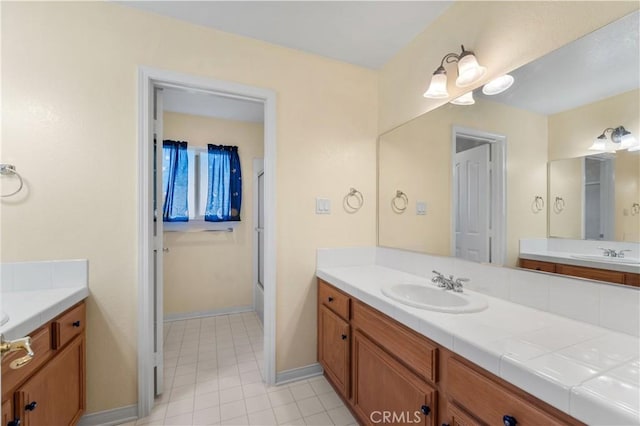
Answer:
[[451, 126, 506, 265]]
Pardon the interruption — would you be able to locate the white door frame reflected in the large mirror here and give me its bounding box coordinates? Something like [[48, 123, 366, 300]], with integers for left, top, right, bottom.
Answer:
[[450, 125, 507, 265]]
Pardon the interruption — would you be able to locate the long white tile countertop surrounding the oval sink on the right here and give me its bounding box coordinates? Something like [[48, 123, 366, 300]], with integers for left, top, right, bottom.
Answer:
[[316, 249, 640, 425]]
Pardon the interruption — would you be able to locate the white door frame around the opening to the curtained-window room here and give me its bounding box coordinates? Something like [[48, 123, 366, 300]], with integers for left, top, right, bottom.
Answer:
[[138, 66, 276, 418]]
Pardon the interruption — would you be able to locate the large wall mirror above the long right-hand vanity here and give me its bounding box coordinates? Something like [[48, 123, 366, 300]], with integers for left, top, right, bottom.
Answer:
[[378, 12, 640, 266]]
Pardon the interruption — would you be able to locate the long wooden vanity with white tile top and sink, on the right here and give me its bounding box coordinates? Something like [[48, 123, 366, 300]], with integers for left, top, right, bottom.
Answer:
[[316, 247, 640, 426]]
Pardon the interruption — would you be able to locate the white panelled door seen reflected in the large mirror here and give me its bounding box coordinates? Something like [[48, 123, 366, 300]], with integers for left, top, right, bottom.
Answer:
[[454, 144, 491, 262]]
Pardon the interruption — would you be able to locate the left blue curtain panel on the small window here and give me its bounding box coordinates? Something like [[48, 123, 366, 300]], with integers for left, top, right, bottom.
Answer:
[[162, 140, 189, 222]]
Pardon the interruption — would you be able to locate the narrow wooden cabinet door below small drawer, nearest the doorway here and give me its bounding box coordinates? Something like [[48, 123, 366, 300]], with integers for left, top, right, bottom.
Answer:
[[318, 305, 350, 398]]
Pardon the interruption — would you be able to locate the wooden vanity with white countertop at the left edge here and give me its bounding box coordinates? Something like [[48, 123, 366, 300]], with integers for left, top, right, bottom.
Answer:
[[0, 260, 89, 426]]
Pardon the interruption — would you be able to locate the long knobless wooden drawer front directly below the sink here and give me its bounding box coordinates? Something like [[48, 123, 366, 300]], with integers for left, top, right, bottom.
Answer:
[[351, 301, 438, 383]]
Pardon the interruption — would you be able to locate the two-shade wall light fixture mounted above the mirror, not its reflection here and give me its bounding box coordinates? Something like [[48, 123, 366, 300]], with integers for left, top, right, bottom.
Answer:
[[423, 45, 487, 99]]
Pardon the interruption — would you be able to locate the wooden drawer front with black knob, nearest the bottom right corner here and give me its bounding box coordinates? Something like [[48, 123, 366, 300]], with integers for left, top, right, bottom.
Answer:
[[447, 358, 566, 426]]
